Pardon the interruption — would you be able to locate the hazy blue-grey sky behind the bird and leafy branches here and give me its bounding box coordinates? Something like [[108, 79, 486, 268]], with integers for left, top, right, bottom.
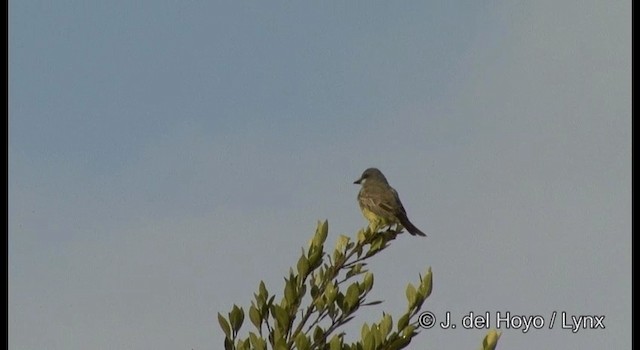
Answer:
[[8, 0, 631, 350]]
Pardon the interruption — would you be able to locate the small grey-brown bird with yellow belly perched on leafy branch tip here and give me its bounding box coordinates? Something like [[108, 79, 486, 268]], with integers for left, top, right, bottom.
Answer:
[[353, 168, 427, 237]]
